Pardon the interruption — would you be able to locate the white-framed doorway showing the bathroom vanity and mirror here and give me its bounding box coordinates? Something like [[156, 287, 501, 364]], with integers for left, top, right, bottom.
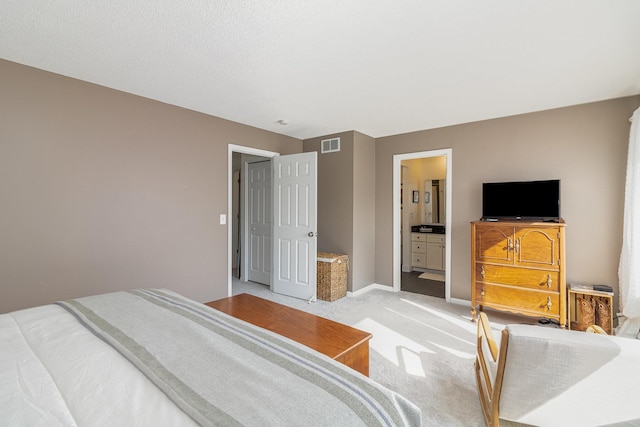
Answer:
[[393, 149, 452, 301]]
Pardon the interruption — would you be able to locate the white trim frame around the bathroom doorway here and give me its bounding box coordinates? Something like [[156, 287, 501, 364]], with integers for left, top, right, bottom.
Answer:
[[393, 148, 453, 302]]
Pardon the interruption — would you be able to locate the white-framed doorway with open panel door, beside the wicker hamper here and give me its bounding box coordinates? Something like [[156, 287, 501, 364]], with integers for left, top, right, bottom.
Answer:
[[229, 144, 318, 300]]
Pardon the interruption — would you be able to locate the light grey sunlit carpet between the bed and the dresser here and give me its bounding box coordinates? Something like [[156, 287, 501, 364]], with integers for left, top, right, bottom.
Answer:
[[233, 281, 536, 427]]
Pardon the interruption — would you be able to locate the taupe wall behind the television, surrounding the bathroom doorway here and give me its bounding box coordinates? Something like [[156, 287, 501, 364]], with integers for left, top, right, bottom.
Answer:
[[376, 96, 640, 310]]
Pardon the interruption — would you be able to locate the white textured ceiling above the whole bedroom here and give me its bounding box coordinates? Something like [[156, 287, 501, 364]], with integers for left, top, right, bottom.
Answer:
[[0, 0, 640, 139]]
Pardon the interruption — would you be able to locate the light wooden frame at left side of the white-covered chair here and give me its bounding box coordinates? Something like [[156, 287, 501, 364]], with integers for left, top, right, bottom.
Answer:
[[475, 312, 509, 427]]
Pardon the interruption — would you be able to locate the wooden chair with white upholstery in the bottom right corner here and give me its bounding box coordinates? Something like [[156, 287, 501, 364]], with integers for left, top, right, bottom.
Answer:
[[475, 312, 640, 427]]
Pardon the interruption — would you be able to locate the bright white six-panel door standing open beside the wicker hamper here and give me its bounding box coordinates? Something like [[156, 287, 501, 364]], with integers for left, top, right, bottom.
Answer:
[[271, 151, 318, 300]]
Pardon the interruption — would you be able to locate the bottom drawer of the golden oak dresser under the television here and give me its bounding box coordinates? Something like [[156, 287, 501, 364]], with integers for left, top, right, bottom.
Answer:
[[476, 283, 560, 317]]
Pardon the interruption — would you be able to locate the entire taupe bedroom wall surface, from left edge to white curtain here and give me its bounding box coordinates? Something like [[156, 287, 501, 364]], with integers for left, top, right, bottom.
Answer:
[[5, 60, 640, 312]]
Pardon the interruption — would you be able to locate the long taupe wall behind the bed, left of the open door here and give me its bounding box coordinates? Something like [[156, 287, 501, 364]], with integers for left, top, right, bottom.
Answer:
[[0, 60, 302, 312]]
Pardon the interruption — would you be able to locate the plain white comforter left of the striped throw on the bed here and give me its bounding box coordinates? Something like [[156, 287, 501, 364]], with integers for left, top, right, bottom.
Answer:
[[0, 305, 197, 427]]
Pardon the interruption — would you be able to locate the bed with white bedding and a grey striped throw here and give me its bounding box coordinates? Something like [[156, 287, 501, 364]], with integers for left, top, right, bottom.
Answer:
[[0, 289, 421, 426]]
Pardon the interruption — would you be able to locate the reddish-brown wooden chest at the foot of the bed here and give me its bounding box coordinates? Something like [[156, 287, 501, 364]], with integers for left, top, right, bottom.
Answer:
[[206, 294, 371, 376]]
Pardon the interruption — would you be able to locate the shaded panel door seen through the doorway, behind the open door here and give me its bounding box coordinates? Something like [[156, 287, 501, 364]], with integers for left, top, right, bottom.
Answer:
[[246, 160, 271, 285]]
